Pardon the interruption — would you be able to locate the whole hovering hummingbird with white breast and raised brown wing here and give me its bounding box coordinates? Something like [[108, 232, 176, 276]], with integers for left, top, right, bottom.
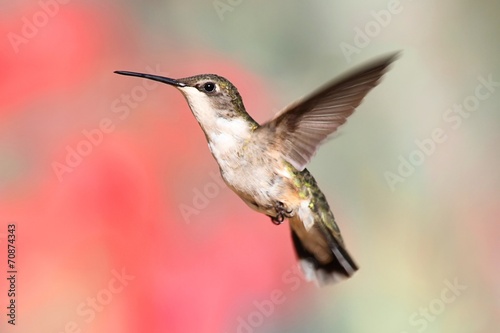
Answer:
[[115, 53, 398, 285]]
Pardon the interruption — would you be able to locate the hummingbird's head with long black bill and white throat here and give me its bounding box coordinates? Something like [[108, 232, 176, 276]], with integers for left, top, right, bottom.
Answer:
[[115, 71, 258, 137]]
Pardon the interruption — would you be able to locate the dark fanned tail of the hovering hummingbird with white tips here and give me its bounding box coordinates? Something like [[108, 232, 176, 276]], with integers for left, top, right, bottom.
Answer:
[[292, 219, 358, 285]]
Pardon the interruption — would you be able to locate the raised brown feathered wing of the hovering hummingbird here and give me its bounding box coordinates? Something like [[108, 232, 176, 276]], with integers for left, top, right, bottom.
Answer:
[[260, 53, 398, 171]]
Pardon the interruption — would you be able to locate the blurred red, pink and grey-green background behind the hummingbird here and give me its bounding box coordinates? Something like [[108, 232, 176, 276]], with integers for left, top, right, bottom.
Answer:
[[0, 0, 500, 333]]
